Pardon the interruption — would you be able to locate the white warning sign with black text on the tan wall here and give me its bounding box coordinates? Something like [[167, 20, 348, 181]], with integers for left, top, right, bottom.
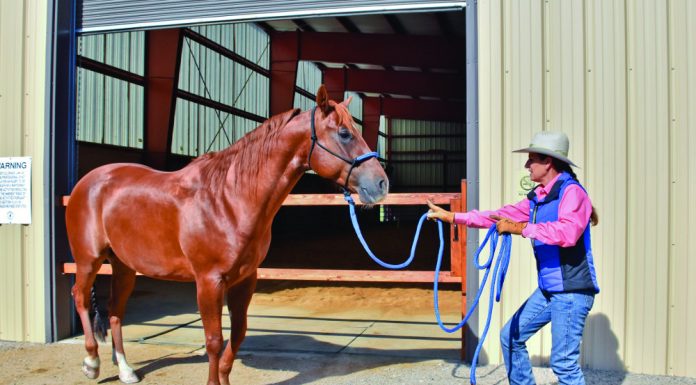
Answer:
[[0, 157, 31, 224]]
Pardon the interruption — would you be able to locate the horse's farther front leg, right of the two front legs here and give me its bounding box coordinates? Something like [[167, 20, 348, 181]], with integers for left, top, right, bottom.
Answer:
[[220, 272, 256, 385]]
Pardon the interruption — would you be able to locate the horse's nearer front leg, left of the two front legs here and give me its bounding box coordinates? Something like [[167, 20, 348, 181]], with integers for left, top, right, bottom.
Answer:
[[196, 276, 225, 385]]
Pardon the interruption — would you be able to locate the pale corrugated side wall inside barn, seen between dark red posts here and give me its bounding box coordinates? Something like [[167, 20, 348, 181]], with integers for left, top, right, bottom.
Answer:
[[77, 23, 370, 156]]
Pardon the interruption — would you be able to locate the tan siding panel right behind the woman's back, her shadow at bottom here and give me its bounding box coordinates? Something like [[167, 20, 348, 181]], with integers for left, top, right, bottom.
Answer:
[[584, 0, 628, 370]]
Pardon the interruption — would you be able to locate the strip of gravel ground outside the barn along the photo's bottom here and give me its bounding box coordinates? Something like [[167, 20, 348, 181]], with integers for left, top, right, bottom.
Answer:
[[0, 341, 696, 385]]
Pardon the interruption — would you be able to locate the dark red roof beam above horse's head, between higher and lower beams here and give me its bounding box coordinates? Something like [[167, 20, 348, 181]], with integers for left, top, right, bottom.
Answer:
[[324, 68, 466, 100]]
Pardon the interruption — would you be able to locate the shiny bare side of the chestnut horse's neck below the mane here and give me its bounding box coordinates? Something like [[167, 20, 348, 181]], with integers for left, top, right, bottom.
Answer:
[[226, 114, 310, 220]]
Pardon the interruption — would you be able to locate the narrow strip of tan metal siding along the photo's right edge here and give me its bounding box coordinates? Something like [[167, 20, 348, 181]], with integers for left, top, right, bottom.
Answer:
[[667, 0, 696, 377]]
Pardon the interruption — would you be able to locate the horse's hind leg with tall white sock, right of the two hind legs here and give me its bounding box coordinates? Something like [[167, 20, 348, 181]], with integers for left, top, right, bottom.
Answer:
[[109, 258, 140, 384]]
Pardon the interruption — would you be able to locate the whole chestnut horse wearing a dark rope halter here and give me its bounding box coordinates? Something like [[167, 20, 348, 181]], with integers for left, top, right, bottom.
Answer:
[[65, 85, 389, 384]]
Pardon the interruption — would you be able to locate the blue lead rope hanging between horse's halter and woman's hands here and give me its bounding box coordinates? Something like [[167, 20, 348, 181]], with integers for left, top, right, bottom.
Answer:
[[344, 193, 512, 384]]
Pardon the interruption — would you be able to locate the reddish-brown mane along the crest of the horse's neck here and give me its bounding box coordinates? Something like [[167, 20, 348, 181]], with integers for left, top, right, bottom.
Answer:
[[190, 109, 301, 192]]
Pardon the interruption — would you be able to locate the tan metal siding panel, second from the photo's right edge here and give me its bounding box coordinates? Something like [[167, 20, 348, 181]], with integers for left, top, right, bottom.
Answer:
[[625, 1, 669, 373]]
